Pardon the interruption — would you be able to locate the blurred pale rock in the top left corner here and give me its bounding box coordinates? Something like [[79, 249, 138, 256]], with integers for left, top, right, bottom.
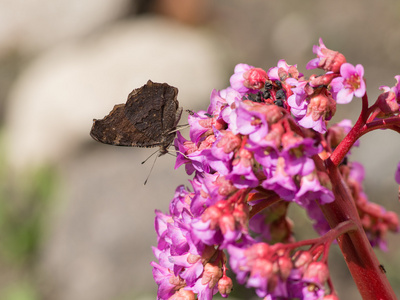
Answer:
[[0, 0, 134, 56]]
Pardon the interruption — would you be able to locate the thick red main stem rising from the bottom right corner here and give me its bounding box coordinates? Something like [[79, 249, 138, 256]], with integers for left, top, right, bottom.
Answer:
[[321, 158, 396, 300]]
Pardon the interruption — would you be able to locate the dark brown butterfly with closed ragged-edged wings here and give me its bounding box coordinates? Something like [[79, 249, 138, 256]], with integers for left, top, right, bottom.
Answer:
[[90, 80, 182, 155]]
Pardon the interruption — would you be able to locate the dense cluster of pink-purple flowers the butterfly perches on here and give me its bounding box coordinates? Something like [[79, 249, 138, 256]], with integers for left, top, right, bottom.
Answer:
[[152, 40, 400, 300]]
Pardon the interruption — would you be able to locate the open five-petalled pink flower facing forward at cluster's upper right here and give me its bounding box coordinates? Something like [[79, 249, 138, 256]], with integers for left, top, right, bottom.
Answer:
[[330, 63, 366, 104]]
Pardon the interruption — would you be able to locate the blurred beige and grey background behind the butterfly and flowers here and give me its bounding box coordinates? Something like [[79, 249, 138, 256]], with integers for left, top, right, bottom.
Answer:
[[0, 0, 400, 300]]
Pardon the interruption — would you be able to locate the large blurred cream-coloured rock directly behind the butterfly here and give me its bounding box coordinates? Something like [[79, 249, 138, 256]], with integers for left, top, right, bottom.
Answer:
[[6, 18, 227, 169]]
